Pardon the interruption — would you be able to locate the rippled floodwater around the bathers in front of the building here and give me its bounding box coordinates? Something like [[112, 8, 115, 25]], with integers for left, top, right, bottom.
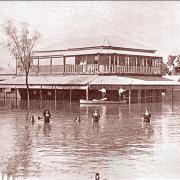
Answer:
[[0, 100, 180, 180]]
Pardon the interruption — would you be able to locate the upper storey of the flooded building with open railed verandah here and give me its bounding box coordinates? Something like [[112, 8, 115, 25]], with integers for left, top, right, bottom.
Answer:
[[17, 46, 162, 76]]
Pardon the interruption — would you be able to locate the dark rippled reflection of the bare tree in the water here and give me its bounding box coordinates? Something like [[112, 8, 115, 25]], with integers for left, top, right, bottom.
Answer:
[[0, 117, 35, 177]]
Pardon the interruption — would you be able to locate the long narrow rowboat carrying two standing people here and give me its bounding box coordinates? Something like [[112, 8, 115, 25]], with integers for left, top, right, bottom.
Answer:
[[80, 99, 127, 104]]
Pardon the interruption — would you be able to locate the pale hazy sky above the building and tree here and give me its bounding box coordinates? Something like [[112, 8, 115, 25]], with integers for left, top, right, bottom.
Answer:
[[0, 1, 180, 67]]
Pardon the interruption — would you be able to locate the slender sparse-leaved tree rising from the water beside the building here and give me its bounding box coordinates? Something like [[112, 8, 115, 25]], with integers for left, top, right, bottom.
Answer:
[[4, 21, 40, 108]]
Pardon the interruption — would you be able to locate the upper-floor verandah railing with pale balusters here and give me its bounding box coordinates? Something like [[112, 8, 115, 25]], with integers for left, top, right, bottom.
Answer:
[[18, 64, 161, 74]]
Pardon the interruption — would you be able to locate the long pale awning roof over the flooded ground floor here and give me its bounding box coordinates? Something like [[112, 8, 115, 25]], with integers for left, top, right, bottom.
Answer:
[[0, 75, 180, 86]]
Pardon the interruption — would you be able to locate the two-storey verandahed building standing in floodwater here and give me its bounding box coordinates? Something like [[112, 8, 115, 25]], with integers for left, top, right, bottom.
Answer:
[[2, 46, 177, 102]]
